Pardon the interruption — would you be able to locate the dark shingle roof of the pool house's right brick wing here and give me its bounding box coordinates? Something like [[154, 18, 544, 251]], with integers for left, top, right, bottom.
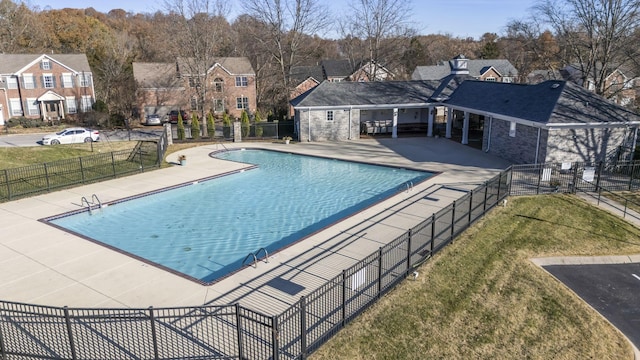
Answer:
[[444, 80, 640, 125]]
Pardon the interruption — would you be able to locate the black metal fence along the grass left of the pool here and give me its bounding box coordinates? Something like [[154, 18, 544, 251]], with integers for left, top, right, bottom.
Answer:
[[0, 139, 166, 202]]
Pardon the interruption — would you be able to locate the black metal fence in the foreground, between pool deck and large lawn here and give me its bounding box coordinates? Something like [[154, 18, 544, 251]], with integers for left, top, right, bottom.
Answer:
[[0, 171, 511, 360]]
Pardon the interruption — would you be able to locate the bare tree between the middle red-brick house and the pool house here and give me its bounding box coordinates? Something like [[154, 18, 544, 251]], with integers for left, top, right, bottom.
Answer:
[[242, 0, 330, 108]]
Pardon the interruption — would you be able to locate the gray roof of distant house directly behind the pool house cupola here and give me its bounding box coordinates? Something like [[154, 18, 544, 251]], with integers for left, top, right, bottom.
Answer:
[[411, 59, 518, 80]]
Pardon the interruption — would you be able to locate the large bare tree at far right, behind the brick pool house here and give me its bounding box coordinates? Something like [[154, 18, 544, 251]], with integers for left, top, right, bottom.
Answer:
[[535, 0, 640, 97]]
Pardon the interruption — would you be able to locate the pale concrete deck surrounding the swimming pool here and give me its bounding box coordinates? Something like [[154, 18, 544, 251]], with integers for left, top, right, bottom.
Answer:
[[0, 137, 509, 315]]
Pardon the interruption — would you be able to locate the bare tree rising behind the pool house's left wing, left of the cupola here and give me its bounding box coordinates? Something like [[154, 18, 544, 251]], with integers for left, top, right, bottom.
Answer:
[[340, 0, 416, 81]]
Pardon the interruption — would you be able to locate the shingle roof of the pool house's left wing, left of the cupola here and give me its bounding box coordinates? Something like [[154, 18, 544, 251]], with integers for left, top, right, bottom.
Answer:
[[291, 81, 440, 108]]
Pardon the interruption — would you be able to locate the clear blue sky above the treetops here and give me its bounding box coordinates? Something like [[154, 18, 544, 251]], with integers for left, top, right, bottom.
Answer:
[[26, 0, 535, 39]]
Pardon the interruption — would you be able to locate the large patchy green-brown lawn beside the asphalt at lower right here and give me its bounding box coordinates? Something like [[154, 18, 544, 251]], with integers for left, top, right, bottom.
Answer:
[[311, 195, 640, 360]]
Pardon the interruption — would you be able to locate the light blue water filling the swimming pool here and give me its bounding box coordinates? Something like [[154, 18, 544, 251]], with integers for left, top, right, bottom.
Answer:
[[50, 150, 433, 283]]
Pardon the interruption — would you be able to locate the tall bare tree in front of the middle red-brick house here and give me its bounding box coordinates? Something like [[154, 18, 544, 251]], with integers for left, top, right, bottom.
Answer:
[[165, 0, 230, 136]]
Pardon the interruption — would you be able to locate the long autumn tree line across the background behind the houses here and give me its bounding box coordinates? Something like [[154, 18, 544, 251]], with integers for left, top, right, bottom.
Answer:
[[0, 0, 640, 121]]
